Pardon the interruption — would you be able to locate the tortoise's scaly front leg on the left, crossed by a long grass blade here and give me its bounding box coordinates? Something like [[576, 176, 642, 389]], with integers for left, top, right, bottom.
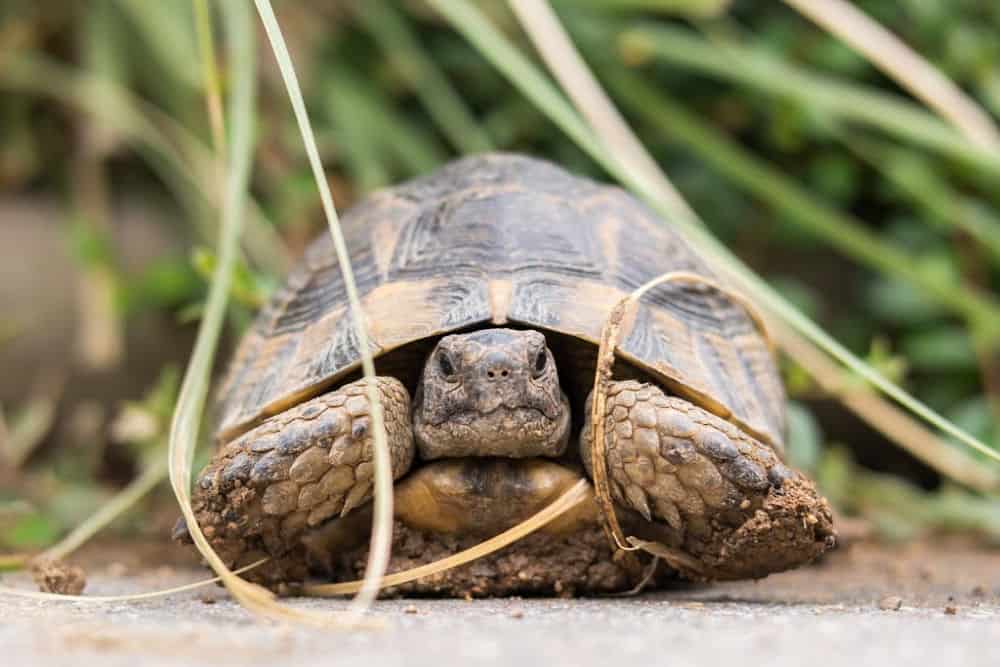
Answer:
[[185, 377, 414, 584]]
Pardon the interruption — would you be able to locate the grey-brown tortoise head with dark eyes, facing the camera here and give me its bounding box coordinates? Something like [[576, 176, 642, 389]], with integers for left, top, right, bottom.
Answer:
[[413, 329, 570, 460]]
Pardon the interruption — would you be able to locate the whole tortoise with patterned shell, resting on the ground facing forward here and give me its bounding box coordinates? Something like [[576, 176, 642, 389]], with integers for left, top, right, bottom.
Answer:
[[178, 153, 835, 596]]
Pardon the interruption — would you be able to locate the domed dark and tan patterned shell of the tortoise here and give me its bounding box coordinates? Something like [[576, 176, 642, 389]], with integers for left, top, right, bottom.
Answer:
[[219, 154, 784, 453]]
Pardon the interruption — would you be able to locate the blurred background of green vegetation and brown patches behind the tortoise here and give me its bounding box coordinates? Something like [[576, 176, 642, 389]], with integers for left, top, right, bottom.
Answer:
[[0, 0, 1000, 564]]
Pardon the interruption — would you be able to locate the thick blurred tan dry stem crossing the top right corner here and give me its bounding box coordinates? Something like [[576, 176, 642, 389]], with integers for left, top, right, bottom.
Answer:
[[785, 0, 1000, 151]]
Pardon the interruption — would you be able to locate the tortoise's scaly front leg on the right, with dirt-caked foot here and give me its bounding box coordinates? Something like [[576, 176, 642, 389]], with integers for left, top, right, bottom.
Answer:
[[580, 381, 835, 579]]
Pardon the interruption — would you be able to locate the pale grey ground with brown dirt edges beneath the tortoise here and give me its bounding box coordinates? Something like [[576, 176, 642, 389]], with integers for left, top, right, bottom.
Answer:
[[0, 544, 1000, 667]]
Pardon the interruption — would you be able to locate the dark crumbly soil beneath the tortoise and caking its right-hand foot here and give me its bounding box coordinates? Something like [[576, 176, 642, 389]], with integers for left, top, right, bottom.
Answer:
[[324, 472, 835, 597]]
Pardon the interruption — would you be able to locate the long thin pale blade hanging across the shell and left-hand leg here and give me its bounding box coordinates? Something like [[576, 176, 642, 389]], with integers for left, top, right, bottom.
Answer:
[[254, 0, 392, 621]]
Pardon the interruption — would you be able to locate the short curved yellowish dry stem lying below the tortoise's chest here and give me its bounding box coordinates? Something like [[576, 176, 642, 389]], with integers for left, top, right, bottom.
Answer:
[[302, 479, 590, 597]]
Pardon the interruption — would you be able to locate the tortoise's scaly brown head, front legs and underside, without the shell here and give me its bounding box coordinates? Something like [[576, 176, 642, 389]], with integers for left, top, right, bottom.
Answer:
[[180, 329, 834, 595]]
